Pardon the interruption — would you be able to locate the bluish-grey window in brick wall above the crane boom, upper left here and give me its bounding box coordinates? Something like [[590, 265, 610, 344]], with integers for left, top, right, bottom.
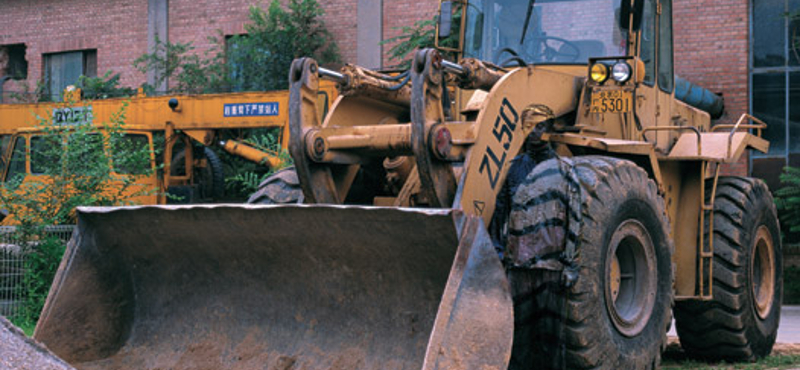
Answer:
[[44, 50, 97, 100]]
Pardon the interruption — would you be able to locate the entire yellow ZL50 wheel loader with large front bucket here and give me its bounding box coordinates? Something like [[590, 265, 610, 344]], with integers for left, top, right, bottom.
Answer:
[[29, 0, 782, 370]]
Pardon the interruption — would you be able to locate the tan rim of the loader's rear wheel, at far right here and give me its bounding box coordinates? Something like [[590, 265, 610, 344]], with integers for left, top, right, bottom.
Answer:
[[750, 225, 775, 320]]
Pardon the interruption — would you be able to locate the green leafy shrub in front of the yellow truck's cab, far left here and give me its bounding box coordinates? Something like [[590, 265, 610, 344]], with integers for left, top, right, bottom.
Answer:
[[0, 102, 155, 327]]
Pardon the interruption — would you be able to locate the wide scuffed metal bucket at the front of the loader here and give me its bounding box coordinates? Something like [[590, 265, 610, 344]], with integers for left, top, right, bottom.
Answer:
[[34, 205, 513, 370]]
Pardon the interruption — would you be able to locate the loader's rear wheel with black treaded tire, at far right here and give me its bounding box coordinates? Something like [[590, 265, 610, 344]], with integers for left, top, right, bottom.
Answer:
[[675, 177, 783, 361]]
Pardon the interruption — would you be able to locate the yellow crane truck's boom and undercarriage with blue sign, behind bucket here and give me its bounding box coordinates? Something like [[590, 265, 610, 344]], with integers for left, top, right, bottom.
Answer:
[[0, 83, 338, 211]]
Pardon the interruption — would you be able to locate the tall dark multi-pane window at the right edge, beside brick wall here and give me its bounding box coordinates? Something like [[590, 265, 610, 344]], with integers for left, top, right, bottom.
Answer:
[[750, 0, 800, 189]]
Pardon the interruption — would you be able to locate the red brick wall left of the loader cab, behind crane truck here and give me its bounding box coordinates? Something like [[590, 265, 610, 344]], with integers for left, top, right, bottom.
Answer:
[[0, 0, 366, 91]]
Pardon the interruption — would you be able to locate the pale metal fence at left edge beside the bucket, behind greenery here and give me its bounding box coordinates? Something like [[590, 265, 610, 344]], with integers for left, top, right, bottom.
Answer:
[[0, 225, 75, 318]]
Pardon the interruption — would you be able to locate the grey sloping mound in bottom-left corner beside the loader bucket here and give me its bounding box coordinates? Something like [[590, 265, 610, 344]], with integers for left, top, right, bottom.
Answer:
[[0, 316, 74, 370]]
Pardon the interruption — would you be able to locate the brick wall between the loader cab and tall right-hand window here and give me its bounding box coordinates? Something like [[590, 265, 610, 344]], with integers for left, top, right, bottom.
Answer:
[[673, 0, 749, 175]]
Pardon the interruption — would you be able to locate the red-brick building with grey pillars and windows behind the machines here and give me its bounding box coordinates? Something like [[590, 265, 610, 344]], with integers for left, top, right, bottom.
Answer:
[[0, 0, 800, 185]]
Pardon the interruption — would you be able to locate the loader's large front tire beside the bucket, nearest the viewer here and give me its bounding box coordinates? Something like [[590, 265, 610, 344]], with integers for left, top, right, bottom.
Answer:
[[509, 156, 673, 369]]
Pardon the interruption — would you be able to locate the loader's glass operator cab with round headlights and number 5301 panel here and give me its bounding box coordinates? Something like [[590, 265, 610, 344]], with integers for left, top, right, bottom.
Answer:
[[436, 0, 689, 145]]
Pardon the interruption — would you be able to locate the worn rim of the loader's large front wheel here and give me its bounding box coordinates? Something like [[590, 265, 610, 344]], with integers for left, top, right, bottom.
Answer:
[[605, 220, 657, 337]]
